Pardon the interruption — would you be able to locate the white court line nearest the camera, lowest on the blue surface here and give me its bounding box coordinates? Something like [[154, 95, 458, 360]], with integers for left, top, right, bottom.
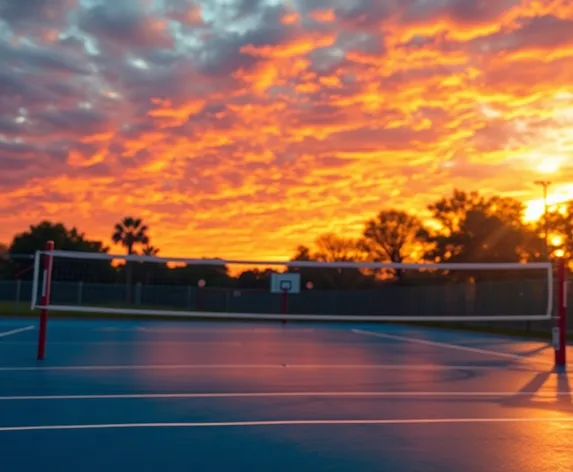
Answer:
[[0, 416, 573, 432]]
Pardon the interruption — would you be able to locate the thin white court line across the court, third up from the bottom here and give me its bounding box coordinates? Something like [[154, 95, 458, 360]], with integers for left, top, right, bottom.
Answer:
[[0, 364, 534, 372]]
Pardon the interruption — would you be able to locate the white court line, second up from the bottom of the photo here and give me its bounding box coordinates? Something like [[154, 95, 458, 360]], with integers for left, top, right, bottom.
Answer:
[[0, 390, 571, 401]]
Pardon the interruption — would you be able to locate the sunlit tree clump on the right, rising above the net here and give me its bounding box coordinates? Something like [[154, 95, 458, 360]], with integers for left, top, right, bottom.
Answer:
[[293, 189, 573, 285]]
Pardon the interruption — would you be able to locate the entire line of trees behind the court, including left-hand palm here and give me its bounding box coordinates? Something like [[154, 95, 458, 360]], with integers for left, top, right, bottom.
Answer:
[[0, 189, 573, 289]]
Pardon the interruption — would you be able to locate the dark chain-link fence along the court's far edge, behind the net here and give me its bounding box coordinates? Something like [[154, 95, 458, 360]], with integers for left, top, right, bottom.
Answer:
[[0, 279, 573, 334]]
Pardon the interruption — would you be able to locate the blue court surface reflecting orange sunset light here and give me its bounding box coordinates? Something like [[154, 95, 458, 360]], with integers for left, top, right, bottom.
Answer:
[[0, 319, 573, 472]]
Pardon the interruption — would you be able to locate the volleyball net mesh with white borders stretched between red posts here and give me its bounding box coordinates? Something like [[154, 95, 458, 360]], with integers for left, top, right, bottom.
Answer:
[[33, 251, 554, 321]]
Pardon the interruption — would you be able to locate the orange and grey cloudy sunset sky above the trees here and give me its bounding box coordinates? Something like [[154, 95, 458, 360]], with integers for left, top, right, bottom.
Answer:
[[0, 0, 573, 259]]
